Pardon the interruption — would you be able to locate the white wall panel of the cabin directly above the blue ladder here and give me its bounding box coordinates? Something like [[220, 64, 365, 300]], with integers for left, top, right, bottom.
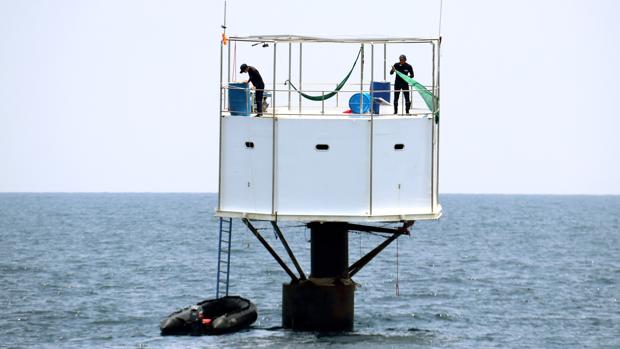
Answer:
[[220, 116, 273, 213]]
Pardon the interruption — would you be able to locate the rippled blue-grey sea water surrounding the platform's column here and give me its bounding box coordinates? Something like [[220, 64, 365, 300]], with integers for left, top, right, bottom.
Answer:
[[0, 194, 620, 348]]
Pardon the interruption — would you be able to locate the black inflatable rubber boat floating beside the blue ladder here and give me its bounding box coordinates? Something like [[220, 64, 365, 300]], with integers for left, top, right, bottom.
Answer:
[[159, 296, 258, 336]]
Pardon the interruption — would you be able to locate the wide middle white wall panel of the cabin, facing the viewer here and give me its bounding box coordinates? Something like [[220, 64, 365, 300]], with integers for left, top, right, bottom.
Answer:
[[276, 119, 370, 216]]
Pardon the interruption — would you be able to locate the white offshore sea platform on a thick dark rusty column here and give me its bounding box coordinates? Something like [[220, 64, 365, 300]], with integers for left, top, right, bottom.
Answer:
[[216, 34, 441, 331]]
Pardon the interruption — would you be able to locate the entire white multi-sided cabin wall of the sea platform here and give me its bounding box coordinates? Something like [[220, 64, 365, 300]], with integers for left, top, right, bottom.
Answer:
[[218, 116, 440, 221]]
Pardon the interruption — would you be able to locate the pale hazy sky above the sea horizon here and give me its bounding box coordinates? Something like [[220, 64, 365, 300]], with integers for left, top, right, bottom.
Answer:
[[0, 0, 620, 194]]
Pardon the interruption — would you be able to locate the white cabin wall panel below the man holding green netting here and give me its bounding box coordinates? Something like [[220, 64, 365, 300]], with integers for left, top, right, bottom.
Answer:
[[372, 118, 433, 215]]
